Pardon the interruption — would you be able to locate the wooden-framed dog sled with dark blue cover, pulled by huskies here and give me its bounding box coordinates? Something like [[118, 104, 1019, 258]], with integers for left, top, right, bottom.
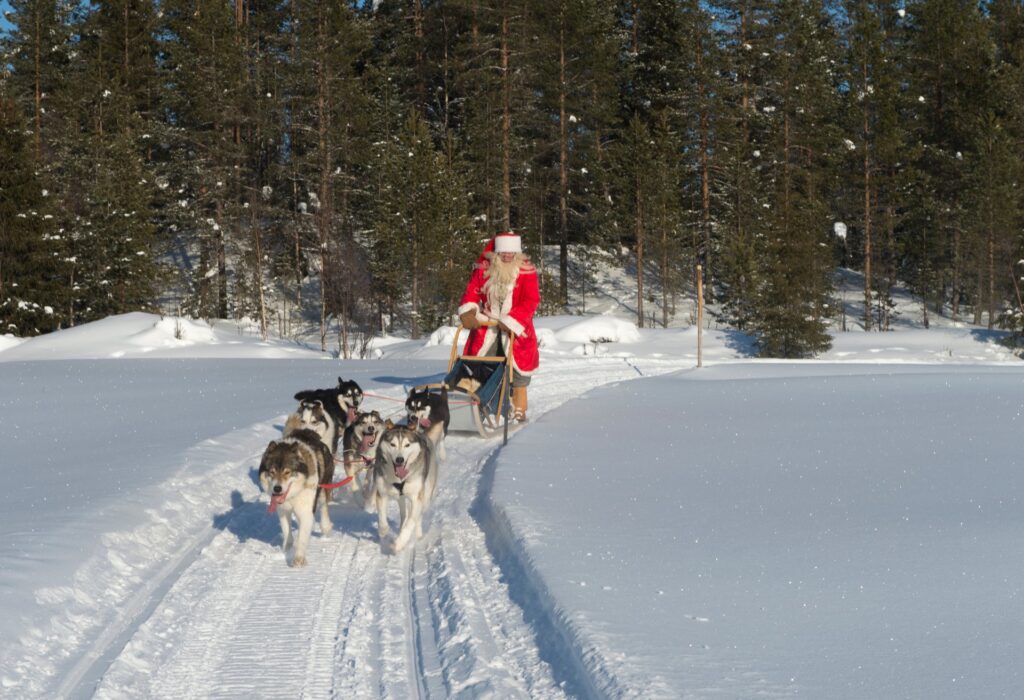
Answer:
[[415, 321, 514, 440]]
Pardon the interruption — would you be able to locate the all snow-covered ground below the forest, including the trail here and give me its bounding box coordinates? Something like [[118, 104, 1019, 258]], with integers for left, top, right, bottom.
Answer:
[[0, 303, 1024, 698]]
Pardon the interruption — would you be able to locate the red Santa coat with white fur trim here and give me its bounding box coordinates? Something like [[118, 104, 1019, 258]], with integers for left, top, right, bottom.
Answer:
[[459, 258, 541, 375]]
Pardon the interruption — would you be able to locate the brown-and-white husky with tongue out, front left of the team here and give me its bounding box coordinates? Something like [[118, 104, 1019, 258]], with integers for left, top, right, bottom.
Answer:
[[259, 428, 334, 566]]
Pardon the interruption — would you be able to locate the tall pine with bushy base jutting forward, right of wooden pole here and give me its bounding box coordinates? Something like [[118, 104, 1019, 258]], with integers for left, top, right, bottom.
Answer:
[[754, 0, 839, 357]]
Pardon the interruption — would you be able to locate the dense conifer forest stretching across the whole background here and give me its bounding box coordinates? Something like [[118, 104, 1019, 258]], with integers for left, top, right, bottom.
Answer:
[[0, 0, 1024, 357]]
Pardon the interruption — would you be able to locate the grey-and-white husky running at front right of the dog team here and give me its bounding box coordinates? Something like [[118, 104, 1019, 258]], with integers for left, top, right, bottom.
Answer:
[[371, 426, 437, 554]]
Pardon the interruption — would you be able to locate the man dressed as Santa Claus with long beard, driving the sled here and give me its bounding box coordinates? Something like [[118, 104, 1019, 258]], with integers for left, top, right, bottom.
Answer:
[[459, 231, 541, 423]]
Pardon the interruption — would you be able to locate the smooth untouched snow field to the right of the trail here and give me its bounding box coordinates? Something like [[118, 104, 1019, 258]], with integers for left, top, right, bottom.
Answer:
[[490, 363, 1024, 699]]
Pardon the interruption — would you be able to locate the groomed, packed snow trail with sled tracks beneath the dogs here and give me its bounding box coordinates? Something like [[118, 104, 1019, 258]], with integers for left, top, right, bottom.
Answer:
[[66, 358, 684, 700]]
